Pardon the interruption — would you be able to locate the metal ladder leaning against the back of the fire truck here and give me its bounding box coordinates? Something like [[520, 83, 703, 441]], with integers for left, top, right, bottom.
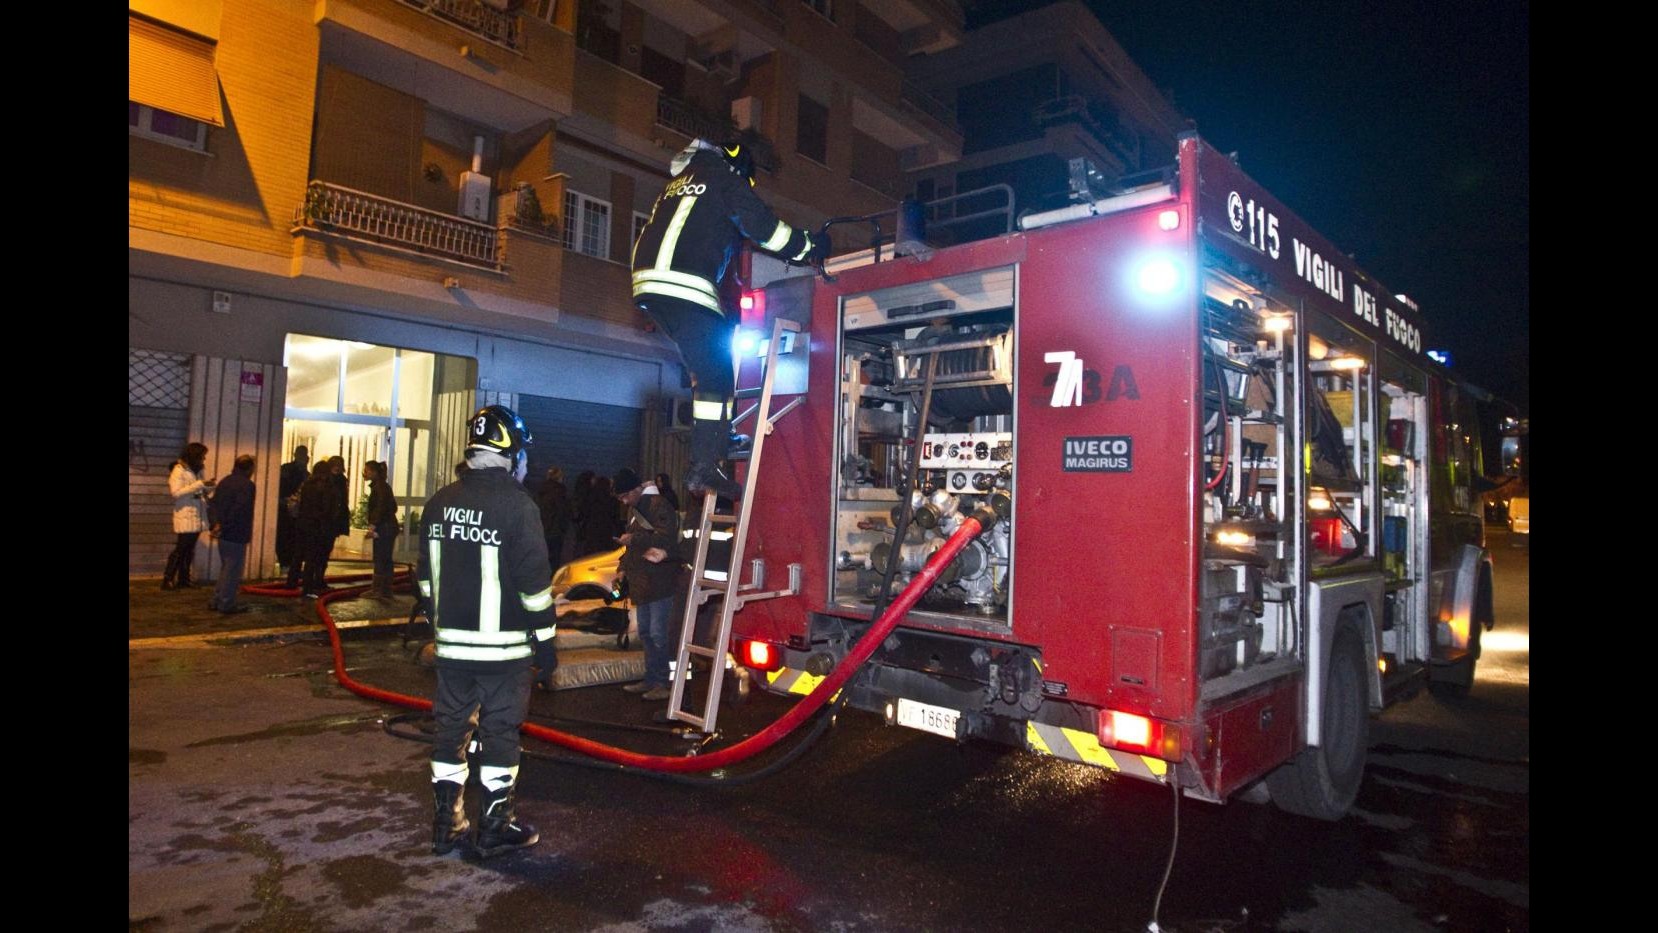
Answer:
[[668, 318, 806, 734]]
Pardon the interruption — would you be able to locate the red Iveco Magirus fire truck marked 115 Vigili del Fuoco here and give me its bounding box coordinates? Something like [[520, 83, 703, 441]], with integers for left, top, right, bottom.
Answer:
[[733, 136, 1494, 819]]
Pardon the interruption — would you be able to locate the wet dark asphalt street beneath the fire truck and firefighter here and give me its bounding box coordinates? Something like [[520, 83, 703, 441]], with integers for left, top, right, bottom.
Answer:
[[128, 529, 1530, 931]]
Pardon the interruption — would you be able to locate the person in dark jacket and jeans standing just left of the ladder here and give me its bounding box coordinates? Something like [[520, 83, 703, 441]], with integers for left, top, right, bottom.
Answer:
[[615, 469, 683, 701]]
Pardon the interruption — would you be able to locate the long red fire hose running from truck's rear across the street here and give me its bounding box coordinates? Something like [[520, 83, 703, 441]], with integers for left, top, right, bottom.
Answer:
[[283, 509, 995, 772]]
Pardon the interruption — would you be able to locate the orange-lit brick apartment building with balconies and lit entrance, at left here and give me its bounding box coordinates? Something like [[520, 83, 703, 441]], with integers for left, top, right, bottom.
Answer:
[[128, 0, 962, 575]]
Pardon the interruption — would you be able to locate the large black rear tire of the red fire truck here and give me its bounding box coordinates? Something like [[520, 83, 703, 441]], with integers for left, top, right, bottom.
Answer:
[[1267, 626, 1370, 822]]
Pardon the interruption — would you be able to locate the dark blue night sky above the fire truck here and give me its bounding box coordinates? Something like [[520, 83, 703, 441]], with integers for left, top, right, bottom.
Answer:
[[967, 0, 1530, 413]]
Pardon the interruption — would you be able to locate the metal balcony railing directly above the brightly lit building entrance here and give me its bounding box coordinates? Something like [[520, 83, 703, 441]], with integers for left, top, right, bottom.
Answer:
[[293, 181, 502, 272]]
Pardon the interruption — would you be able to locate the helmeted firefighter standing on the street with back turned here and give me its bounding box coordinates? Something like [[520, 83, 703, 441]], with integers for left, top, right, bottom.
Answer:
[[416, 404, 559, 858]]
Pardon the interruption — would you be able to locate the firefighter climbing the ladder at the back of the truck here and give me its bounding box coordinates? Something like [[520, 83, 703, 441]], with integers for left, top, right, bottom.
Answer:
[[633, 139, 829, 500]]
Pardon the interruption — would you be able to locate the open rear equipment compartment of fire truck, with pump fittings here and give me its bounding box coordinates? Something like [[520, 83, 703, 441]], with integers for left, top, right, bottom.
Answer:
[[832, 268, 1015, 633]]
